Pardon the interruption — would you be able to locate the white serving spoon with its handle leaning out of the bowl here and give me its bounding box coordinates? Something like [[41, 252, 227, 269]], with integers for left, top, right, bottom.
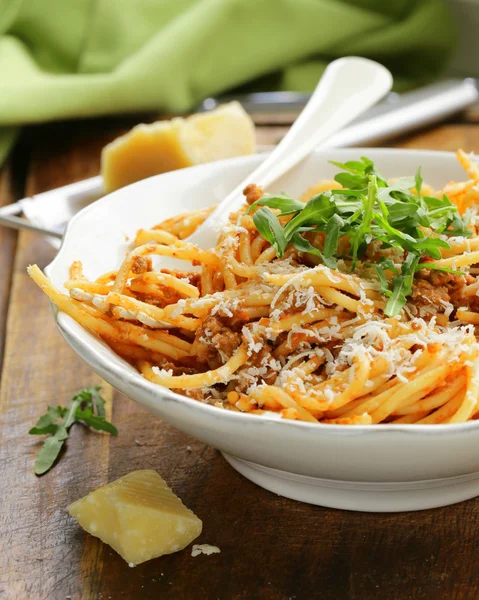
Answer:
[[187, 56, 393, 249]]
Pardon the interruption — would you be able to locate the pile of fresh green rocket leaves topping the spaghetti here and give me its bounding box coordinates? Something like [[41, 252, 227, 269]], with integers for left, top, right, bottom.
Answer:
[[248, 157, 471, 316]]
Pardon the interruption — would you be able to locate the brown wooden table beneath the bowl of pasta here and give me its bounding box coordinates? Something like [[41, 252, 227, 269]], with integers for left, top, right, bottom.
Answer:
[[0, 110, 479, 600]]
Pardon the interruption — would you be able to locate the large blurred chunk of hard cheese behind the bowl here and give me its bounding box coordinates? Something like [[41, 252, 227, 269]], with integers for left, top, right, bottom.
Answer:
[[101, 102, 255, 192]]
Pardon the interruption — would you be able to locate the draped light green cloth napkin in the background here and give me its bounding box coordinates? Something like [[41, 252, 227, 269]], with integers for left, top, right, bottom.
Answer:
[[0, 0, 455, 162]]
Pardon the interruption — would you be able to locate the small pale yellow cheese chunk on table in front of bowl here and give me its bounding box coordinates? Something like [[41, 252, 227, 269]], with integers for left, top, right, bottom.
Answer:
[[68, 470, 203, 566]]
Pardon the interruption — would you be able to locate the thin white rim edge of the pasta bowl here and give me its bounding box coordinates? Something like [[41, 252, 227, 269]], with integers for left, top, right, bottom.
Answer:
[[45, 147, 479, 436]]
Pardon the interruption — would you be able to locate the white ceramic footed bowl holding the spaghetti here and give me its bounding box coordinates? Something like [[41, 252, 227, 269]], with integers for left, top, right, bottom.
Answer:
[[47, 149, 479, 511]]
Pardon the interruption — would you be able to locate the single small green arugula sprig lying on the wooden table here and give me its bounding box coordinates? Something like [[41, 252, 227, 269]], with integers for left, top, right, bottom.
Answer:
[[28, 387, 118, 475]]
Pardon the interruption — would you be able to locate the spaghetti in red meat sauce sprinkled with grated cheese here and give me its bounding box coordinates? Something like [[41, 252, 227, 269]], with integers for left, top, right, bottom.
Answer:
[[29, 151, 479, 424]]
